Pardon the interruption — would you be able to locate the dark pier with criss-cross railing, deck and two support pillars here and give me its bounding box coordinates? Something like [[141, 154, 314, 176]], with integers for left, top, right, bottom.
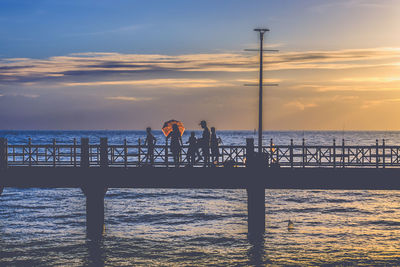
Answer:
[[0, 138, 400, 238]]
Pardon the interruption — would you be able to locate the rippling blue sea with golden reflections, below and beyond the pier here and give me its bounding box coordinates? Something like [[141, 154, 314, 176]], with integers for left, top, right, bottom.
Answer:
[[0, 131, 400, 266]]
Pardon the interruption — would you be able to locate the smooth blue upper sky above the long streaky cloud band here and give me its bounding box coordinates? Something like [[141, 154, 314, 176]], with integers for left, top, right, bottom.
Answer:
[[0, 0, 398, 58]]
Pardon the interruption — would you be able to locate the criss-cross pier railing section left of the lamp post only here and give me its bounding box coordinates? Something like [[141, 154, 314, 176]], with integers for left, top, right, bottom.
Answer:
[[2, 139, 246, 167]]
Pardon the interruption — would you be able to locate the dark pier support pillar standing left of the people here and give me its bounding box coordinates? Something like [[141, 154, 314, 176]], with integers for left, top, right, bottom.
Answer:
[[82, 185, 107, 240]]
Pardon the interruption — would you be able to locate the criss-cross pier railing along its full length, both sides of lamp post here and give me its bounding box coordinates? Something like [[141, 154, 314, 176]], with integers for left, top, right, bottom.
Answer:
[[0, 138, 400, 168]]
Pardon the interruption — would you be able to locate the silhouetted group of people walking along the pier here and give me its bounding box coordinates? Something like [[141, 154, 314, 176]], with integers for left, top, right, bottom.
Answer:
[[145, 120, 222, 167]]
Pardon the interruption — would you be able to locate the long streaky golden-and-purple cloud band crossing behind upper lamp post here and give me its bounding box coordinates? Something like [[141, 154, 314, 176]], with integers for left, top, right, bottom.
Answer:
[[0, 48, 400, 90]]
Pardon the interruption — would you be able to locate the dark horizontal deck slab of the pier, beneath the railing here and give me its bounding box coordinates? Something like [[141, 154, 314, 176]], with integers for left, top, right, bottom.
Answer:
[[0, 167, 400, 190]]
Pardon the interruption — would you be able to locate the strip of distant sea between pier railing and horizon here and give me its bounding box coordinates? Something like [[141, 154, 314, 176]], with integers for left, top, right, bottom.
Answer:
[[0, 129, 400, 145]]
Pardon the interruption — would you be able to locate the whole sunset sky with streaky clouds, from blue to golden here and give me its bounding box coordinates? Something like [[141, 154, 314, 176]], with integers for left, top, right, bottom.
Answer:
[[0, 0, 400, 131]]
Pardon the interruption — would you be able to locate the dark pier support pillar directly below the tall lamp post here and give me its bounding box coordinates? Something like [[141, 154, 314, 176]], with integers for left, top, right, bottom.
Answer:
[[246, 186, 265, 235]]
